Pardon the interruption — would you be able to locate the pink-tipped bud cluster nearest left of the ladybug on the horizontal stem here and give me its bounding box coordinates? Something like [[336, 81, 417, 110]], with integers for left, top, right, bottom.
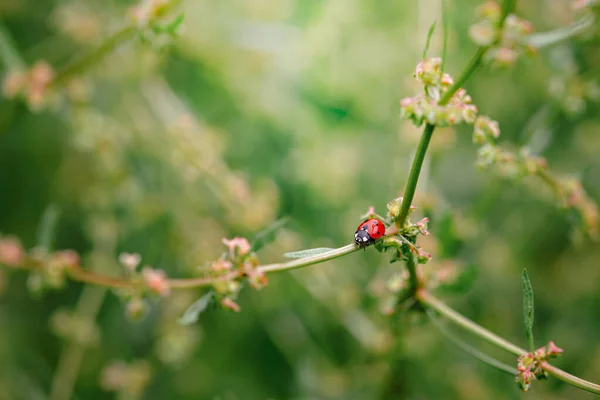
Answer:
[[200, 237, 269, 312]]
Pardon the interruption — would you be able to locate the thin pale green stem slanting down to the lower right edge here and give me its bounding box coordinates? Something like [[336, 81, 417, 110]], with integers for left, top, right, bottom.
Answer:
[[416, 289, 600, 394]]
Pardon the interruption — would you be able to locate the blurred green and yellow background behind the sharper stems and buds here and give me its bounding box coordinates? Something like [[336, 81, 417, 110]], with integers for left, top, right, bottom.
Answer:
[[0, 0, 600, 400]]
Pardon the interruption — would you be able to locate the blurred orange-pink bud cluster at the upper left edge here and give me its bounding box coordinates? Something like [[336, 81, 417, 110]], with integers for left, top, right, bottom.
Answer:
[[2, 61, 54, 111]]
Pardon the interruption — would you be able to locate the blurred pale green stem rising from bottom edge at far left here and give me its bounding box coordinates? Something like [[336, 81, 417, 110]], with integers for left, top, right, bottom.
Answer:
[[50, 286, 106, 400]]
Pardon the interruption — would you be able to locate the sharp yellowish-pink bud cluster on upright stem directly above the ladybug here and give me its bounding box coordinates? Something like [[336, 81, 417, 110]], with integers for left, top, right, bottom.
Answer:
[[400, 57, 477, 127]]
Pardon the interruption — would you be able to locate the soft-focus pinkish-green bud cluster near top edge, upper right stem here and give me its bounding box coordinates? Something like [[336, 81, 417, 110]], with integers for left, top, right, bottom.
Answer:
[[469, 1, 534, 67]]
